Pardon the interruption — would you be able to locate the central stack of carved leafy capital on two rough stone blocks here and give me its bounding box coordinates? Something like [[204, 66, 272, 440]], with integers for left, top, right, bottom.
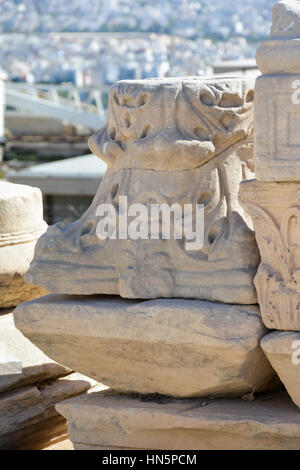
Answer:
[[14, 74, 300, 449]]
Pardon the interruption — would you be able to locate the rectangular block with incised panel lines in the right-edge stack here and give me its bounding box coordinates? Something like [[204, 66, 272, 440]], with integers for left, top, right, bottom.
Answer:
[[254, 75, 300, 181]]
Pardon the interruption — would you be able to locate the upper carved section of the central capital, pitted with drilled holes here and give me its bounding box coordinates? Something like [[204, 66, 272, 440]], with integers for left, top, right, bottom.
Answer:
[[89, 77, 254, 171]]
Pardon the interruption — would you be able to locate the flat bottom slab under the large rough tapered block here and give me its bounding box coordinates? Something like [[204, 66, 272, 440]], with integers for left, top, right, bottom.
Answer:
[[56, 392, 300, 450]]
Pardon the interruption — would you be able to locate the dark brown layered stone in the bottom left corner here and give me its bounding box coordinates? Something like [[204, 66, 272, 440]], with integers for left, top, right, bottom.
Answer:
[[0, 374, 94, 450]]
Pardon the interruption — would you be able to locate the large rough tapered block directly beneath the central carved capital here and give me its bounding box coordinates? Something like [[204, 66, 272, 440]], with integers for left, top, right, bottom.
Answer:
[[14, 295, 274, 397]]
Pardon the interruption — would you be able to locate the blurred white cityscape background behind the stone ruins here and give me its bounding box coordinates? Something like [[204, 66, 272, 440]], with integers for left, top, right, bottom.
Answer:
[[0, 0, 275, 223]]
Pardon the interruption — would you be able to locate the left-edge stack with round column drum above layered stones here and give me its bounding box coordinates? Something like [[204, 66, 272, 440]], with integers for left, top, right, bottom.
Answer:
[[0, 182, 92, 449]]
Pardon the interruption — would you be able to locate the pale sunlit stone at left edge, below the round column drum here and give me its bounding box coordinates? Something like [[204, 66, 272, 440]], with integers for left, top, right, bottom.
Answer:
[[0, 312, 70, 393]]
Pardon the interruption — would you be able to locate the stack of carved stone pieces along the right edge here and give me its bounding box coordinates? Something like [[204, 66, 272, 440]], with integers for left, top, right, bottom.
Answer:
[[240, 0, 300, 407]]
